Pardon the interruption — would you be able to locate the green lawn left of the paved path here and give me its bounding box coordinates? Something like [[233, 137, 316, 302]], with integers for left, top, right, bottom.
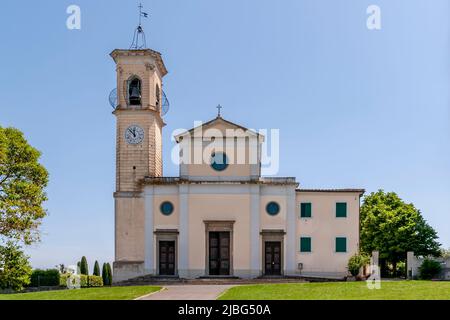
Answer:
[[0, 286, 161, 300]]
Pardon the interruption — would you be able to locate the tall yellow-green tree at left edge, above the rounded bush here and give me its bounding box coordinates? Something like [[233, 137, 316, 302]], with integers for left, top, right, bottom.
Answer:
[[0, 127, 48, 244]]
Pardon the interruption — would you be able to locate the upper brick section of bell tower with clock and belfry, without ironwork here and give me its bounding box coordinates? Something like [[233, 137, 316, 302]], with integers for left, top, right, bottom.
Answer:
[[111, 49, 167, 192]]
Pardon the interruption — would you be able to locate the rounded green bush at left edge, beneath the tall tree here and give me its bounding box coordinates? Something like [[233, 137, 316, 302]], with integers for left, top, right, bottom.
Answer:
[[0, 241, 32, 291]]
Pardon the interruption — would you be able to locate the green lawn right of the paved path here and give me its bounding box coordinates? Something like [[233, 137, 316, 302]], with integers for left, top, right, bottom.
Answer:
[[219, 281, 450, 300]]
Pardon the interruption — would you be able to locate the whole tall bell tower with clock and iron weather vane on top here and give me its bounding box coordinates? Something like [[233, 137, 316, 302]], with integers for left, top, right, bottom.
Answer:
[[110, 5, 168, 281]]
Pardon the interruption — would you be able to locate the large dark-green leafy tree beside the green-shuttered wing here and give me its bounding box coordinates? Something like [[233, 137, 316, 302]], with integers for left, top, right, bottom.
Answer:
[[360, 190, 440, 274]]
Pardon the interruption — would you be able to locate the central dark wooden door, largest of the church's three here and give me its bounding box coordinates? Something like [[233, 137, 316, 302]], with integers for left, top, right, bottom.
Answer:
[[209, 232, 230, 275]]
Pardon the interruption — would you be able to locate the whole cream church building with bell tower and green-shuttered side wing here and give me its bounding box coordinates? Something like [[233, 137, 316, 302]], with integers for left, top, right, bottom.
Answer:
[[111, 49, 364, 282]]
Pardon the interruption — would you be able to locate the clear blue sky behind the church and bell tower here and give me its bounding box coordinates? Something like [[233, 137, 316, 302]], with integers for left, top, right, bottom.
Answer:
[[0, 0, 450, 267]]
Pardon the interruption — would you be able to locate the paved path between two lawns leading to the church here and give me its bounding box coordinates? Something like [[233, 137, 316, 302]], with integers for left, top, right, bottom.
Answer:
[[139, 284, 233, 300]]
